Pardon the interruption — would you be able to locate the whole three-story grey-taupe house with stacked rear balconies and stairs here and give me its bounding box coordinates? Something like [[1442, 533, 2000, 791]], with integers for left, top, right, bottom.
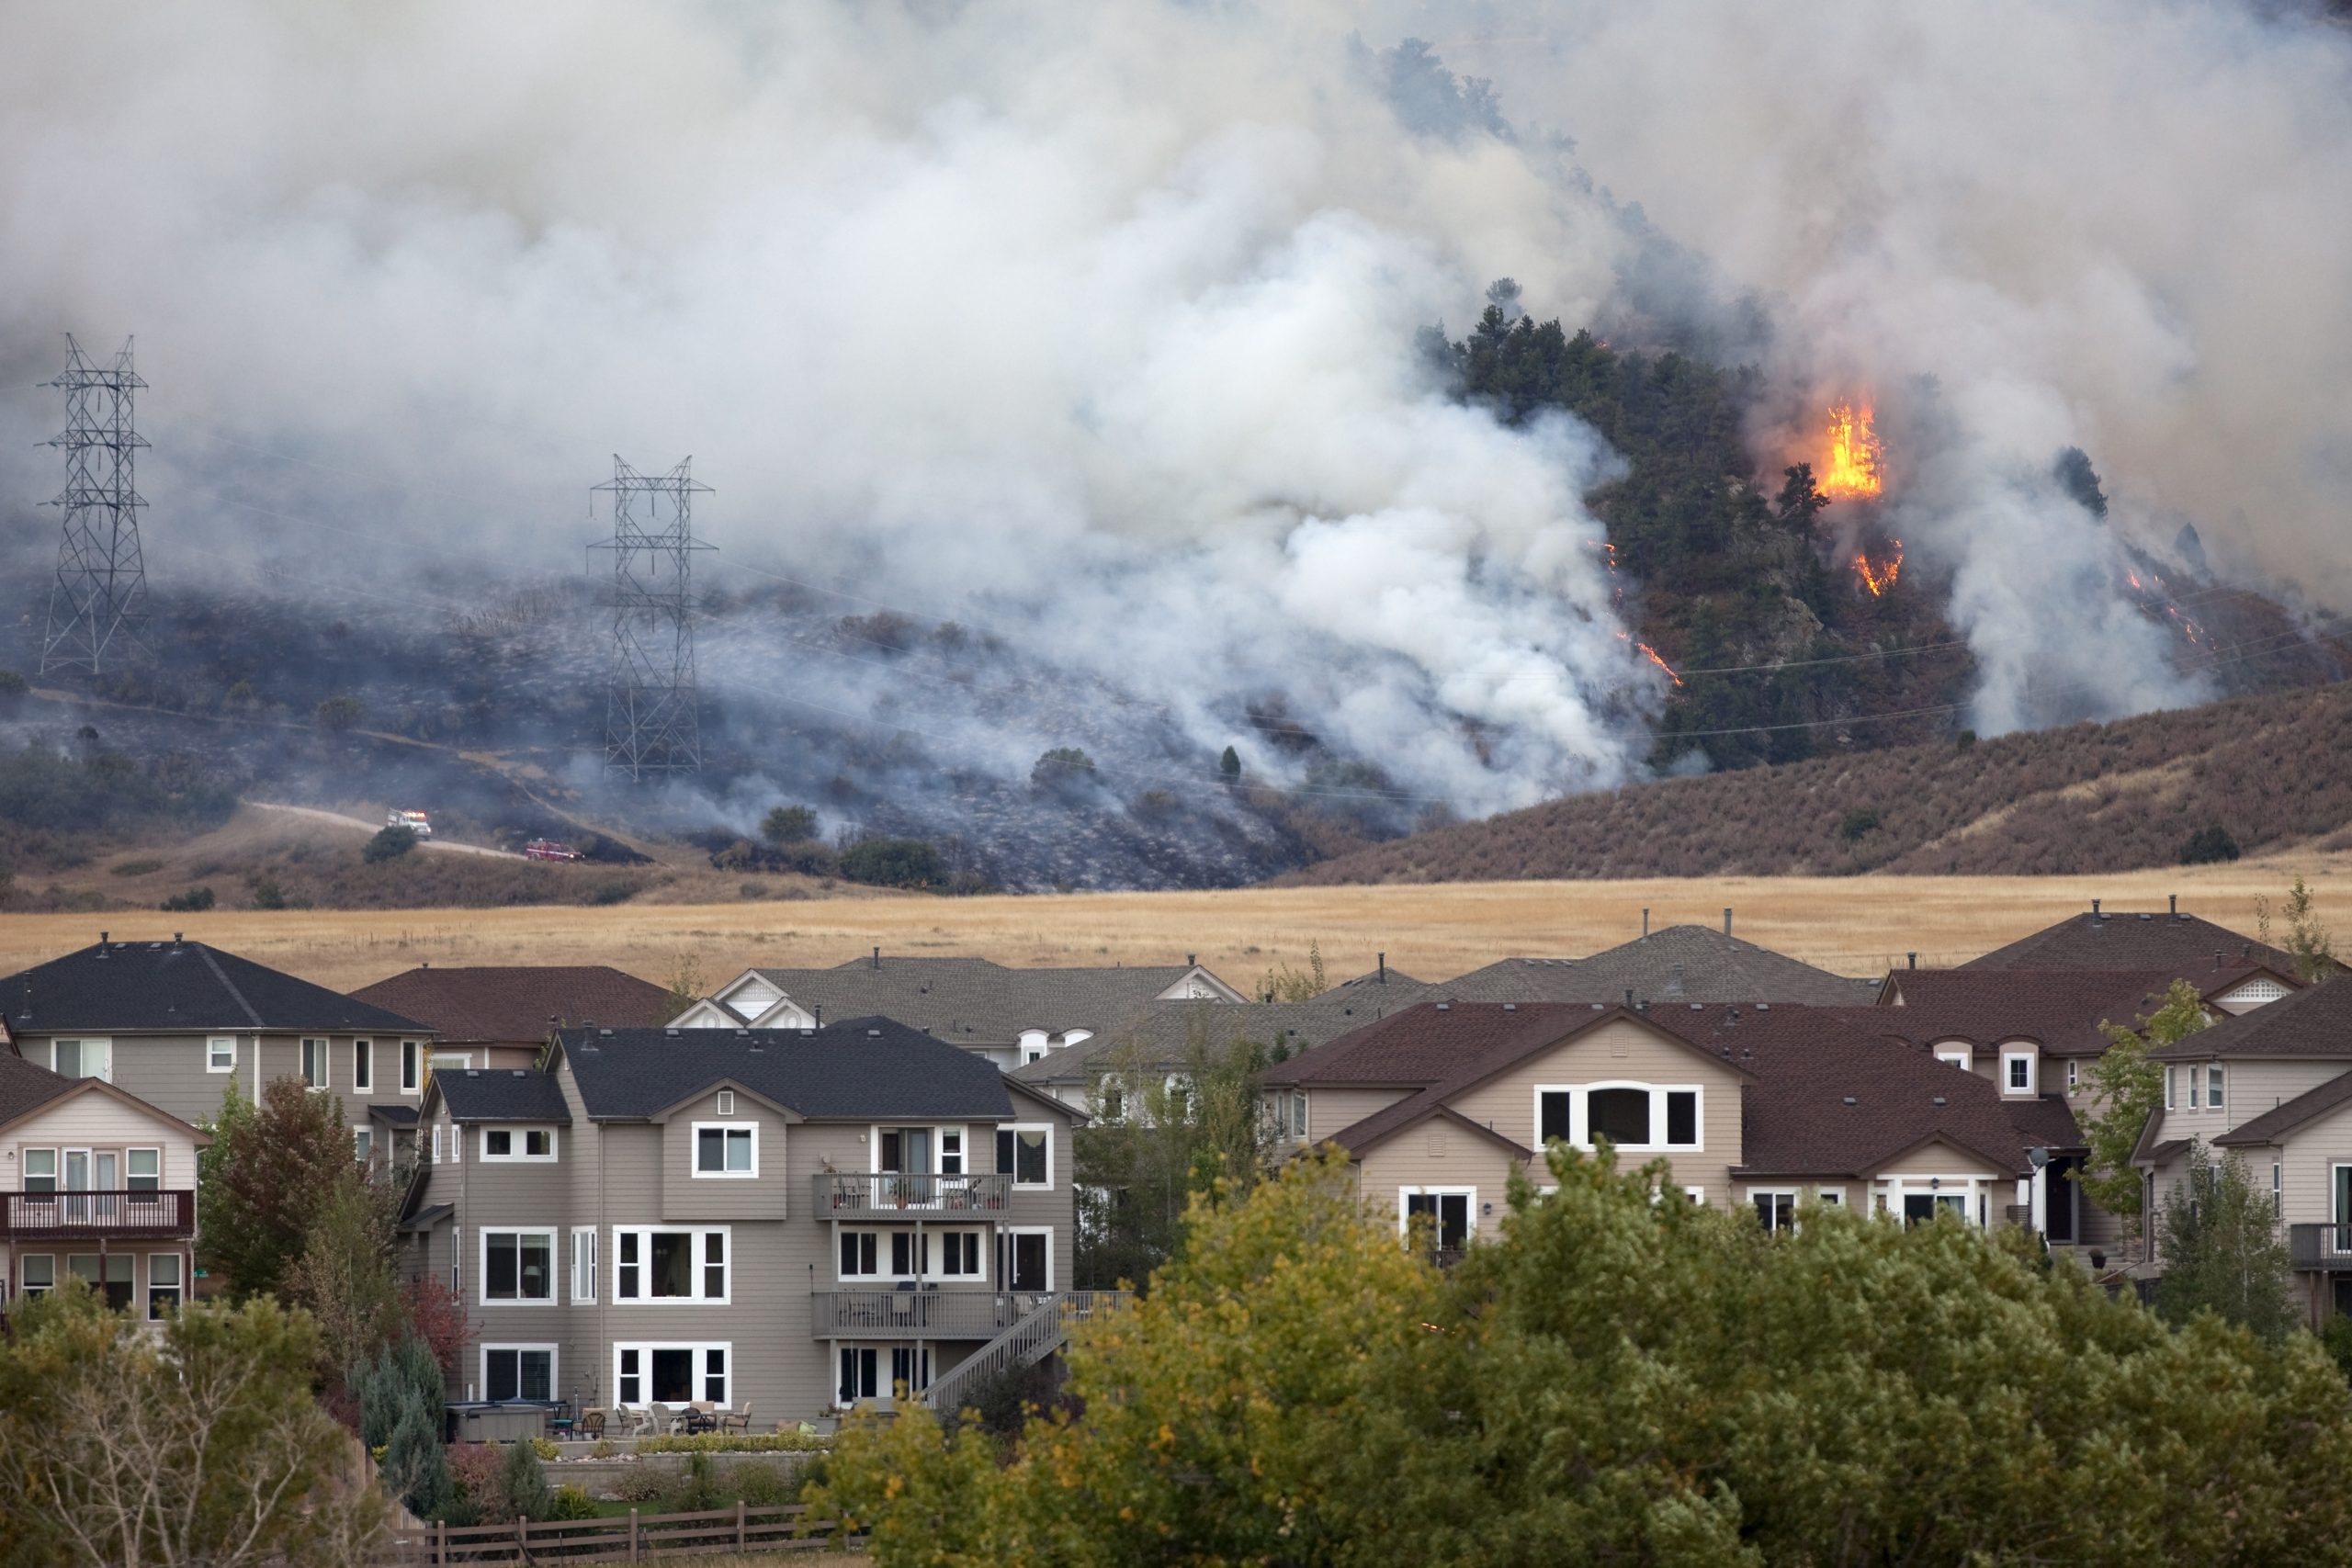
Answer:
[[402, 1018, 1087, 1425]]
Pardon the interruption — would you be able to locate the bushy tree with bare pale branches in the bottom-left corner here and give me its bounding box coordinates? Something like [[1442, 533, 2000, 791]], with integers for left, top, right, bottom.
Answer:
[[0, 1288, 386, 1568]]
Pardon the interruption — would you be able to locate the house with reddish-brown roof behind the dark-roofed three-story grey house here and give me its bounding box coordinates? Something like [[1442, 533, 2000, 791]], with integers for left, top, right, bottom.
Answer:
[[350, 964, 677, 1067]]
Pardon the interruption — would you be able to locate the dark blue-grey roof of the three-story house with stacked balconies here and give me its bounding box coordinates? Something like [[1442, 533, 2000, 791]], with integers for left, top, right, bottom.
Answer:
[[569, 1018, 1013, 1122]]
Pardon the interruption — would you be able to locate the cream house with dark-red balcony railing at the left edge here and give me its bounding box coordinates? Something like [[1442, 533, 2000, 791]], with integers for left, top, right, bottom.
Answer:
[[0, 1054, 211, 1321]]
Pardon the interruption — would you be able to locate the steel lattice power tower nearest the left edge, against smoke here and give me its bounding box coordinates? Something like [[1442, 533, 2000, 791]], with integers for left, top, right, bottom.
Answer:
[[40, 333, 146, 674]]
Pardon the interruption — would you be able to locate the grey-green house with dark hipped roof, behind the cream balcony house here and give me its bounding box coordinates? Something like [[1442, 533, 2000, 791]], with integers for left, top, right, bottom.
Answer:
[[0, 931, 433, 1159]]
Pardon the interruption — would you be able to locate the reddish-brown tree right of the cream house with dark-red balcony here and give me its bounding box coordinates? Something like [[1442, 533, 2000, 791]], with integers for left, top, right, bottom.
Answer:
[[198, 1079, 357, 1300]]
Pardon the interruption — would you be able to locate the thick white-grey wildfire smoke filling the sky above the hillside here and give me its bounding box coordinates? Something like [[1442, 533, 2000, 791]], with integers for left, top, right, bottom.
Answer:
[[0, 0, 2352, 811]]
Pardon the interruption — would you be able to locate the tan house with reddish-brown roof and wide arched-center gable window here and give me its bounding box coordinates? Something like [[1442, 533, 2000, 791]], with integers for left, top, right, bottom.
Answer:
[[1265, 1001, 2070, 1251]]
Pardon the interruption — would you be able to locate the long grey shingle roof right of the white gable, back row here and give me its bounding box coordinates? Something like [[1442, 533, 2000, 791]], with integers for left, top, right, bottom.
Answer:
[[719, 954, 1241, 1046]]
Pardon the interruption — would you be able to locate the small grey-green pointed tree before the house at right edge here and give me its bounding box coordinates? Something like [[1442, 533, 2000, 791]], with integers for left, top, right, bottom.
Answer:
[[2157, 1143, 2302, 1340]]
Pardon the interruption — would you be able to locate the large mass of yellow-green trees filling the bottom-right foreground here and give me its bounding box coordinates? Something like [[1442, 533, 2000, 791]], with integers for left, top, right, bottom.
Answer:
[[832, 1149, 2352, 1568]]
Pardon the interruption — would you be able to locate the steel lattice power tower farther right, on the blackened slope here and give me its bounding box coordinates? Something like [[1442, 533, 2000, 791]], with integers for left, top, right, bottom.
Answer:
[[595, 456, 710, 781]]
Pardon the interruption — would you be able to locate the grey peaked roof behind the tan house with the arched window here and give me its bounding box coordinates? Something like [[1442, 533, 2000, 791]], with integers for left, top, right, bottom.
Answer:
[[1428, 926, 1879, 1006]]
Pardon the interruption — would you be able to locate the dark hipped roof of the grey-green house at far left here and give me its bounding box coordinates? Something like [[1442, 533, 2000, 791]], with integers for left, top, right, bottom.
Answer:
[[0, 942, 430, 1034]]
